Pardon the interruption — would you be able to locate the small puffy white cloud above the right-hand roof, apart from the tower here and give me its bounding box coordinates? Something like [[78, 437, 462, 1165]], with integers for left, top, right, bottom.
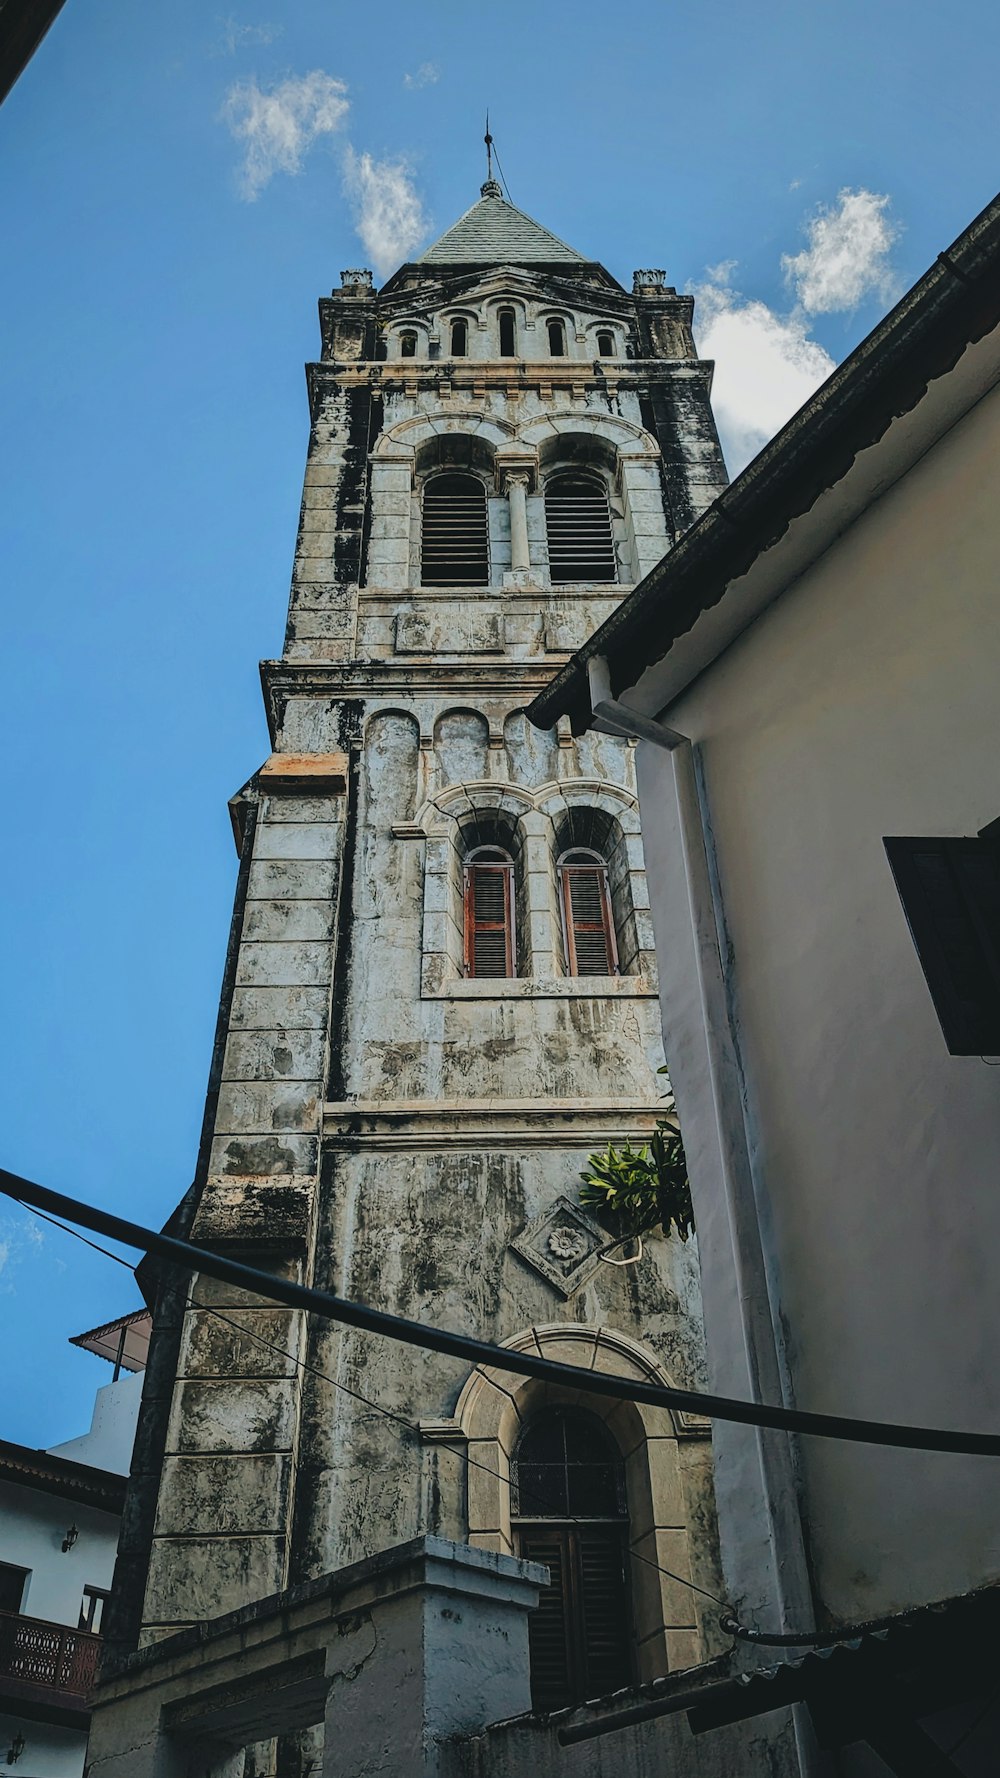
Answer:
[[781, 187, 899, 315]]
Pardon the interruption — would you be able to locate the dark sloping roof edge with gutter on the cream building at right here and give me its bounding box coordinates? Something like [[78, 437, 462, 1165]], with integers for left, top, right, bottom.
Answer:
[[527, 184, 1000, 734]]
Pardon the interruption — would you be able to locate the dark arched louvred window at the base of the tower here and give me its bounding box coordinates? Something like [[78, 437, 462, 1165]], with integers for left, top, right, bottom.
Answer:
[[511, 1408, 632, 1710]]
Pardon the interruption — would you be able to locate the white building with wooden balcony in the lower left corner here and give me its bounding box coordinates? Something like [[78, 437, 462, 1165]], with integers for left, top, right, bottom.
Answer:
[[0, 1309, 149, 1778]]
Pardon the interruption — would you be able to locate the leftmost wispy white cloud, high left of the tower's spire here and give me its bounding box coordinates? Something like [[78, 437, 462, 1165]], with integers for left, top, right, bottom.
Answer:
[[222, 68, 351, 203]]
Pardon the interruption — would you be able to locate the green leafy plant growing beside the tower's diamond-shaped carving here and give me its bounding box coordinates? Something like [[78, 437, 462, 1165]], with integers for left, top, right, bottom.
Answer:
[[580, 1069, 694, 1241]]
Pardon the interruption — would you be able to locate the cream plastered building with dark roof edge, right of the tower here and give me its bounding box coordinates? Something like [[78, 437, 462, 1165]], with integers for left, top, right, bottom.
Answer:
[[528, 187, 1000, 1773]]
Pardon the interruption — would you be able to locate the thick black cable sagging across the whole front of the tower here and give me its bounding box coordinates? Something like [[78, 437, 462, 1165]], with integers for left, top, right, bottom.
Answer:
[[0, 1168, 1000, 1456]]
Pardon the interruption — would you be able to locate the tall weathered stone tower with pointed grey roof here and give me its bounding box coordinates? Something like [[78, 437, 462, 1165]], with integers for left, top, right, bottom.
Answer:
[[104, 180, 726, 1769]]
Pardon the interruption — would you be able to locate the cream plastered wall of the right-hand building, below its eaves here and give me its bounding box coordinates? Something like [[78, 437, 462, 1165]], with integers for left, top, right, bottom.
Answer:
[[639, 371, 1000, 1622]]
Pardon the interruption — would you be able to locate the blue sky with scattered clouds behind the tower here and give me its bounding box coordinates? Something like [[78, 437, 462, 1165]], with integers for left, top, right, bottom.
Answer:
[[0, 0, 1000, 1446]]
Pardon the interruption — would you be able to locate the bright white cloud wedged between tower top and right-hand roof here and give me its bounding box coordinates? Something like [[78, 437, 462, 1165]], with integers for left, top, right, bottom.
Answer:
[[694, 265, 835, 475]]
